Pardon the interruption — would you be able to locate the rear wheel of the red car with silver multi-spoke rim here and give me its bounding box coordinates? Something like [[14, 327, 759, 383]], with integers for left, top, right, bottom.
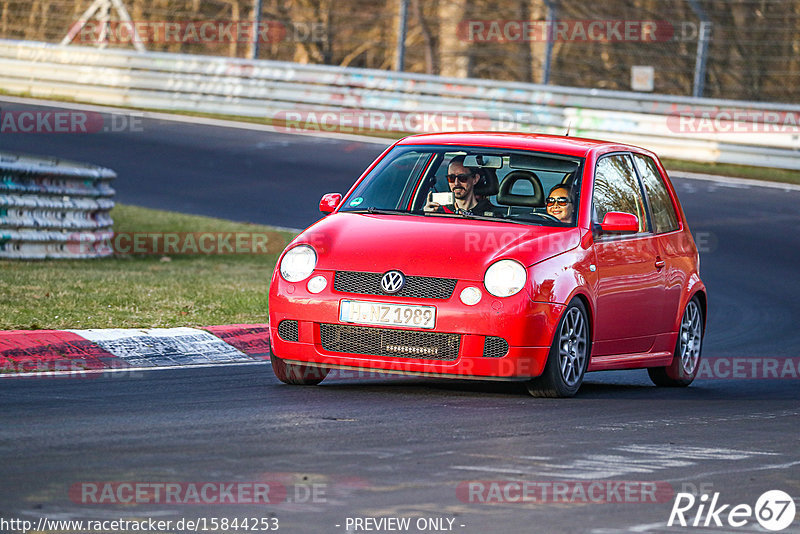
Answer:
[[647, 297, 703, 387]]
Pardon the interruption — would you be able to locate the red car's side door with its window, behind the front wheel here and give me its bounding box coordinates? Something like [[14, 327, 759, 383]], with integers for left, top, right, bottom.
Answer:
[[592, 153, 664, 356]]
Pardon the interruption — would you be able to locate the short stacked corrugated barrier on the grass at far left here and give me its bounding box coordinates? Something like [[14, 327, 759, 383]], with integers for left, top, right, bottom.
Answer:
[[0, 152, 116, 259]]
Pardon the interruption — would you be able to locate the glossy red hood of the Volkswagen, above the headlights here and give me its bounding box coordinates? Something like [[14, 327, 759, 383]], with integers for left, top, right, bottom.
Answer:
[[293, 213, 580, 280]]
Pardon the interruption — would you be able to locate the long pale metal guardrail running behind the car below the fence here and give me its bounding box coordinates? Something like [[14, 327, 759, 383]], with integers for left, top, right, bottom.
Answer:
[[0, 40, 800, 169]]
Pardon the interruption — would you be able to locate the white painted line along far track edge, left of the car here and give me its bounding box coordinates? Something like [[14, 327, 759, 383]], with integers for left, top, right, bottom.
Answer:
[[0, 95, 390, 147]]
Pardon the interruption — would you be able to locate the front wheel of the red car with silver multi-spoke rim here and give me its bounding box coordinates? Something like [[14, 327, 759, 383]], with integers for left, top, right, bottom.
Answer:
[[526, 299, 591, 397]]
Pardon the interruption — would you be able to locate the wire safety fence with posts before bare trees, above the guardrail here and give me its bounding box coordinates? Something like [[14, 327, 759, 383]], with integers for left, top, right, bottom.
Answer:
[[0, 0, 800, 103]]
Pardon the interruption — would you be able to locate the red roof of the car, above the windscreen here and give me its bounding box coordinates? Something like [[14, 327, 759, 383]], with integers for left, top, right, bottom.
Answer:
[[397, 132, 648, 157]]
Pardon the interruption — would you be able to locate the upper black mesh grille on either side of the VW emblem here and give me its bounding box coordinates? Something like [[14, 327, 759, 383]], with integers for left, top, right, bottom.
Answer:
[[333, 271, 457, 299]]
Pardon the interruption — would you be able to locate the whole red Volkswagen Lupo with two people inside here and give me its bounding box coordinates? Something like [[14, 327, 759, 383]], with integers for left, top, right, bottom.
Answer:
[[269, 133, 706, 397]]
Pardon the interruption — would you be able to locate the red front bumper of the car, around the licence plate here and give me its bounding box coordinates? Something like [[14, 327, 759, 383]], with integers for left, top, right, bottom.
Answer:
[[269, 271, 564, 379]]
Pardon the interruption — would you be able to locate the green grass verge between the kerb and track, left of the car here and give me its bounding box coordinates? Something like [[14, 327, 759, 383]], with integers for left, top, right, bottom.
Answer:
[[0, 204, 292, 330]]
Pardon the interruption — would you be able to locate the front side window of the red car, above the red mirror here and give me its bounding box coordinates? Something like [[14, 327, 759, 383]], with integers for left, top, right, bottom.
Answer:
[[592, 154, 649, 232]]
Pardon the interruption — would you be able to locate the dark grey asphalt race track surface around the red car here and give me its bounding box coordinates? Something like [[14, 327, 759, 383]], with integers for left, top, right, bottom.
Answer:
[[0, 101, 800, 534]]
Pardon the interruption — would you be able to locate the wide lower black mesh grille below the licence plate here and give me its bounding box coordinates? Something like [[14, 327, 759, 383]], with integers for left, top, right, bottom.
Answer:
[[319, 324, 461, 361]]
